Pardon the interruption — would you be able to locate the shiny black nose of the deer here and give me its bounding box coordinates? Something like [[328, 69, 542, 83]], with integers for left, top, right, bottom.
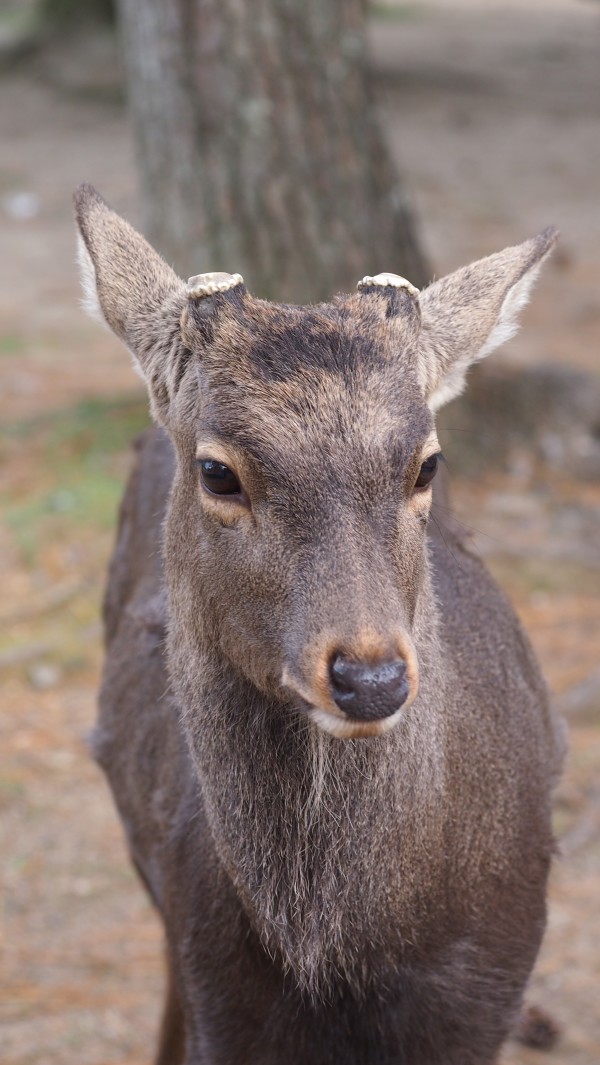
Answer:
[[329, 654, 408, 721]]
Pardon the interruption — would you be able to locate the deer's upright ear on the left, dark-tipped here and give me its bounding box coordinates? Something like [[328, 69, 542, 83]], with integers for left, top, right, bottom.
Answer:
[[75, 184, 187, 424]]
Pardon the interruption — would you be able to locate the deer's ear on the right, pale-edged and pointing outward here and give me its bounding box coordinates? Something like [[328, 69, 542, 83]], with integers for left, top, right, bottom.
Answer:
[[419, 228, 557, 411]]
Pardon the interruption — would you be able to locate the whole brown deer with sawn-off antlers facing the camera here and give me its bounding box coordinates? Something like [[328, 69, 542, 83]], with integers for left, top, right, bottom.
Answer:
[[75, 184, 565, 1065]]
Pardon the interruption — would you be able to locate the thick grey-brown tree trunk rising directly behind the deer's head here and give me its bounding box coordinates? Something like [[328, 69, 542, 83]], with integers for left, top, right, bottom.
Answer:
[[119, 0, 429, 302]]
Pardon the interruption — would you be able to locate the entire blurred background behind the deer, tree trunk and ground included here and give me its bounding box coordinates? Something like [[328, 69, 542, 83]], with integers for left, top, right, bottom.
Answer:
[[0, 0, 600, 1065]]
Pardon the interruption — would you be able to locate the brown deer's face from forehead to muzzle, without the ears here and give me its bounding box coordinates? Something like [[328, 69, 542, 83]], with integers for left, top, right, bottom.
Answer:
[[167, 293, 439, 736]]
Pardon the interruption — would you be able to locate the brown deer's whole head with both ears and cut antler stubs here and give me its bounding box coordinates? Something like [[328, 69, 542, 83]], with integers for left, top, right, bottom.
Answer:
[[78, 186, 553, 737]]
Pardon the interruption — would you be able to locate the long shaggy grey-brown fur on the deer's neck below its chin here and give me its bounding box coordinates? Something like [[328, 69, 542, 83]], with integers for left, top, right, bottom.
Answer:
[[166, 570, 444, 997]]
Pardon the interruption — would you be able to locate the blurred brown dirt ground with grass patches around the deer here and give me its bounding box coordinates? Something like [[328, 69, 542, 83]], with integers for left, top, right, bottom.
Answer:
[[0, 0, 600, 1065]]
